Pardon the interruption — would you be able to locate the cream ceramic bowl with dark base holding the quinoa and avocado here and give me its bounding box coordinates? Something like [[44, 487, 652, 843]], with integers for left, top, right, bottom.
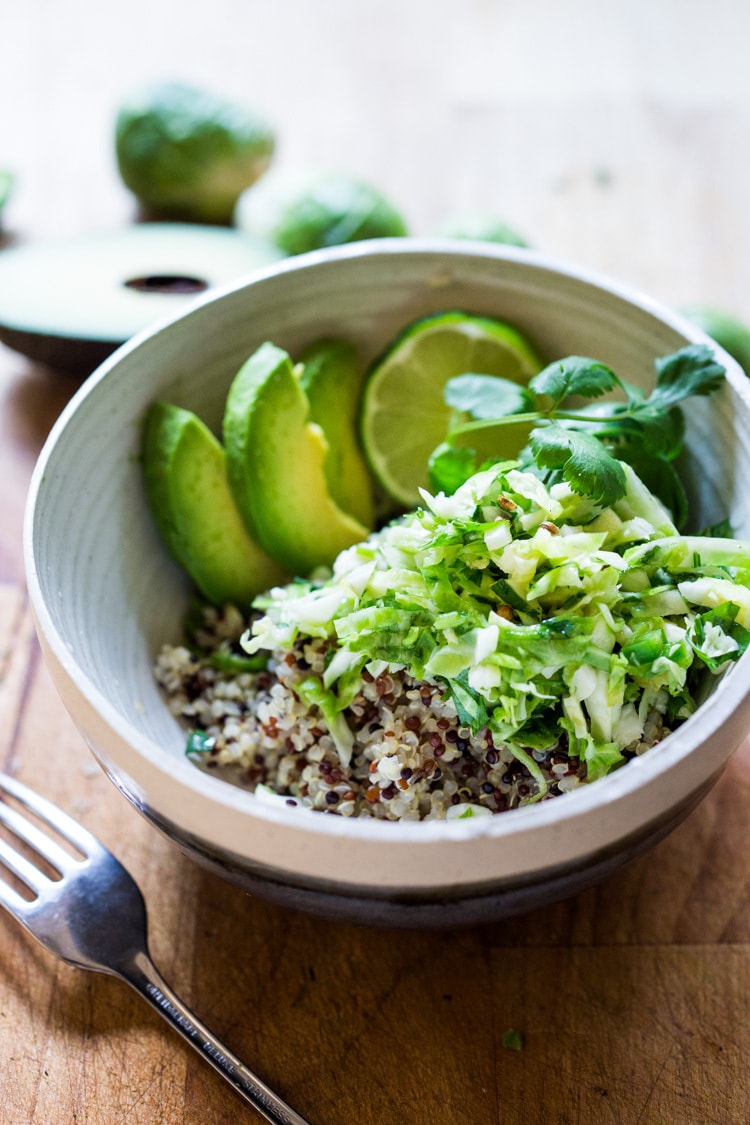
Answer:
[[25, 240, 750, 925]]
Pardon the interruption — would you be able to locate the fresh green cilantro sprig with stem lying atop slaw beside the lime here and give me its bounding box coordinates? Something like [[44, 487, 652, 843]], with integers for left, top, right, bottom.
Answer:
[[430, 344, 725, 525]]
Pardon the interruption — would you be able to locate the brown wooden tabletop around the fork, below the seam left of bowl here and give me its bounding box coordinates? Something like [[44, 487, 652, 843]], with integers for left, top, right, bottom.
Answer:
[[0, 571, 750, 1125]]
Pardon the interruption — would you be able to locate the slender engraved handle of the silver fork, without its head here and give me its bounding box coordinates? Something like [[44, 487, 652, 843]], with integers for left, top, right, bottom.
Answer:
[[118, 952, 309, 1125]]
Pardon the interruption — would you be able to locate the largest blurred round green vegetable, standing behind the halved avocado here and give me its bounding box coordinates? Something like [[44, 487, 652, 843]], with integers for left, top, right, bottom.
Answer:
[[115, 82, 275, 225]]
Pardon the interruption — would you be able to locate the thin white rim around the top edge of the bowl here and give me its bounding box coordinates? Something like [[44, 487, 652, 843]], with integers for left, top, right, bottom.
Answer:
[[24, 237, 750, 845]]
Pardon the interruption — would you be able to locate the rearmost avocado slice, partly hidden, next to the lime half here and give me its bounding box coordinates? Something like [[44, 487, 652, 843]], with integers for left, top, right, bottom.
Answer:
[[299, 340, 374, 528]]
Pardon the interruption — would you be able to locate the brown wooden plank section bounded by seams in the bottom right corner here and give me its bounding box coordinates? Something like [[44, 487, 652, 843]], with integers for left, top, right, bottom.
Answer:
[[493, 945, 750, 1125]]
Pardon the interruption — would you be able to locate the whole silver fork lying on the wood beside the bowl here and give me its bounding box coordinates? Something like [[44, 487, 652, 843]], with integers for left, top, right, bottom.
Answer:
[[0, 773, 308, 1125]]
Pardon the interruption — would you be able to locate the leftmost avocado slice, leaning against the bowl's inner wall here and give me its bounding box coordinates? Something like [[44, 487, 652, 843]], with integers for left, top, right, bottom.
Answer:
[[143, 403, 288, 609]]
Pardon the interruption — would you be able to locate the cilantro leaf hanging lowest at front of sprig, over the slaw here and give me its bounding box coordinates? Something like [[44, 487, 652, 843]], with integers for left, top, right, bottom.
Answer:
[[530, 422, 626, 507]]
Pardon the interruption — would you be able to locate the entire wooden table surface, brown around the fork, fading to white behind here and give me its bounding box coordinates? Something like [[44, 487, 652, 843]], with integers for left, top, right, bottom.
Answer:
[[0, 0, 750, 1125]]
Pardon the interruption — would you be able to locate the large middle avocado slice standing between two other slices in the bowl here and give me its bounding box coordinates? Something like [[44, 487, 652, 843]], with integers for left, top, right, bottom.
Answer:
[[224, 343, 368, 576]]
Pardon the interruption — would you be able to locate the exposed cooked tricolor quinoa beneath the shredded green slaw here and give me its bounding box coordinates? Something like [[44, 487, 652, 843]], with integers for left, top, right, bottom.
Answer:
[[155, 608, 668, 820]]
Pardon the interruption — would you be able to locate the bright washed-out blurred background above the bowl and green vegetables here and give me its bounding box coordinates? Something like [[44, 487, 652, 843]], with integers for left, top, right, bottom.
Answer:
[[0, 0, 750, 315]]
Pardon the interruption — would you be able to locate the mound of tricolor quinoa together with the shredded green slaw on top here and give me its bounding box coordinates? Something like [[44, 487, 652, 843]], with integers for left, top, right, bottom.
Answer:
[[155, 462, 750, 820]]
